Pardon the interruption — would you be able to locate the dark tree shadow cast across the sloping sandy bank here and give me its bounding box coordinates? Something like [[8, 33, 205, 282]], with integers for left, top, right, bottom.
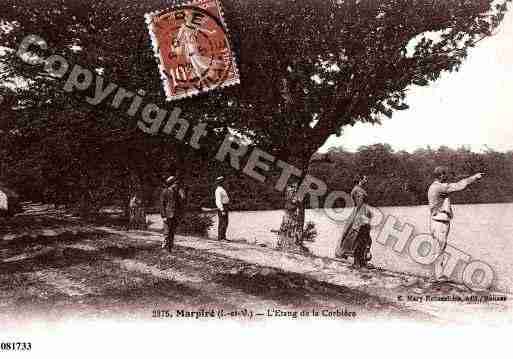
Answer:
[[0, 228, 432, 319]]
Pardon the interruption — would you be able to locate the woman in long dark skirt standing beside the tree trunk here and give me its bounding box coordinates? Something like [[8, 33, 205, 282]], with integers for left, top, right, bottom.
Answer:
[[335, 176, 372, 268]]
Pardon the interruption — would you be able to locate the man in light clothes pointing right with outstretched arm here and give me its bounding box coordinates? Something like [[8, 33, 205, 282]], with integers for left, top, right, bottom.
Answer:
[[428, 166, 483, 280]]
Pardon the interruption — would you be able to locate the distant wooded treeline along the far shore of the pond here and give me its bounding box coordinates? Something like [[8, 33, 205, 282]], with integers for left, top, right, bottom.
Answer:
[[213, 144, 513, 209]]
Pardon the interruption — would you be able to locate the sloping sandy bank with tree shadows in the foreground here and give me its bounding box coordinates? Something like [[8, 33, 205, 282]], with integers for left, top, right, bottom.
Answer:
[[0, 204, 512, 326]]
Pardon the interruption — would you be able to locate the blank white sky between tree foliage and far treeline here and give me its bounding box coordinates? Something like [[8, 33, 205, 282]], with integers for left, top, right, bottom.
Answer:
[[320, 10, 513, 152]]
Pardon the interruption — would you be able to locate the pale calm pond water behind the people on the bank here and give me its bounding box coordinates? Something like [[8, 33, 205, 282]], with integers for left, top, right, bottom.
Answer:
[[151, 203, 513, 292]]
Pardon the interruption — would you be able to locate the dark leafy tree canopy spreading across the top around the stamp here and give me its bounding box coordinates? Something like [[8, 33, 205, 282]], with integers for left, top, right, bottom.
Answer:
[[0, 0, 508, 210]]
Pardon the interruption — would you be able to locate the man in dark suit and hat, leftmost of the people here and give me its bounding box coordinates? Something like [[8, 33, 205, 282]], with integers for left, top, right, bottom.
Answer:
[[160, 176, 185, 252]]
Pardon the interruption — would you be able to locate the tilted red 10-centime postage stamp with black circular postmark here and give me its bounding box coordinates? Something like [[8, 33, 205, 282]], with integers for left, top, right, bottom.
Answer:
[[145, 0, 240, 101]]
